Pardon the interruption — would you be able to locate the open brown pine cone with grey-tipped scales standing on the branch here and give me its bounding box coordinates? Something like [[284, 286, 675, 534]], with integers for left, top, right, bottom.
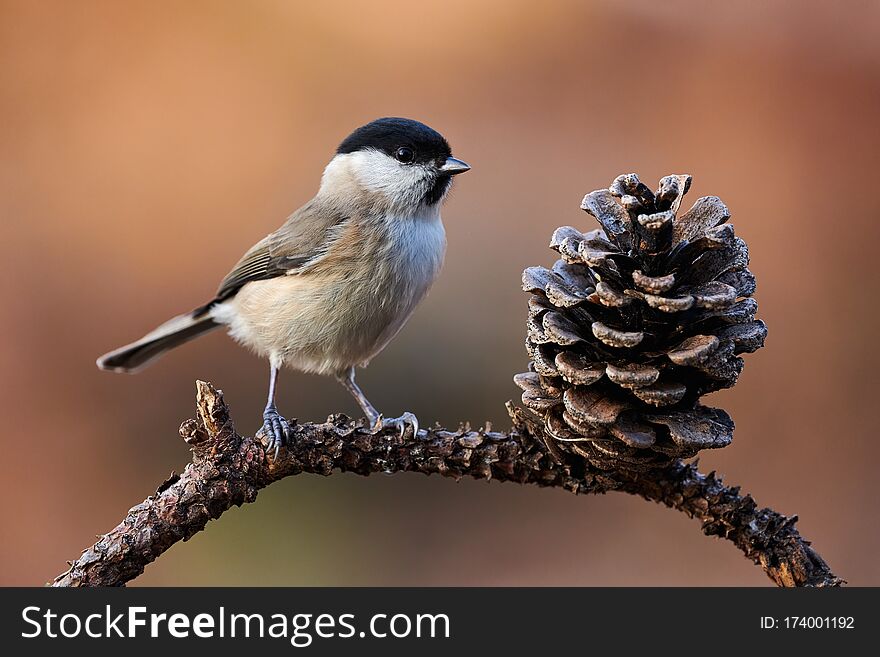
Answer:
[[515, 174, 767, 470]]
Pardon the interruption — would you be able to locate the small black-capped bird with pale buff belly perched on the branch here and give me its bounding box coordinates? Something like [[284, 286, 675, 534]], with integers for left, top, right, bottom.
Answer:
[[97, 117, 470, 459]]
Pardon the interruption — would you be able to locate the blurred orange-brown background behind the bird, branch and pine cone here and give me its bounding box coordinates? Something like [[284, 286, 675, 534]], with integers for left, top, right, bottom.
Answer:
[[0, 0, 880, 586]]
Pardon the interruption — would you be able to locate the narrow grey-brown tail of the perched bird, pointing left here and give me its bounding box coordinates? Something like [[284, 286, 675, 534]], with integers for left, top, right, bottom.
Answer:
[[97, 304, 220, 374]]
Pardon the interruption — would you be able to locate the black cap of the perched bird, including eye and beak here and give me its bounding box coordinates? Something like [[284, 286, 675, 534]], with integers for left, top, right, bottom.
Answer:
[[336, 117, 470, 175]]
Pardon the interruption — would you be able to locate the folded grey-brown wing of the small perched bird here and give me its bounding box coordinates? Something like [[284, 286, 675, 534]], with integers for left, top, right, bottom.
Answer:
[[215, 204, 347, 302]]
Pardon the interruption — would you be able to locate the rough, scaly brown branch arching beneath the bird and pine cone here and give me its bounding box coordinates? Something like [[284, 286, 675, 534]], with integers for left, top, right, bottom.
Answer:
[[52, 381, 843, 586]]
